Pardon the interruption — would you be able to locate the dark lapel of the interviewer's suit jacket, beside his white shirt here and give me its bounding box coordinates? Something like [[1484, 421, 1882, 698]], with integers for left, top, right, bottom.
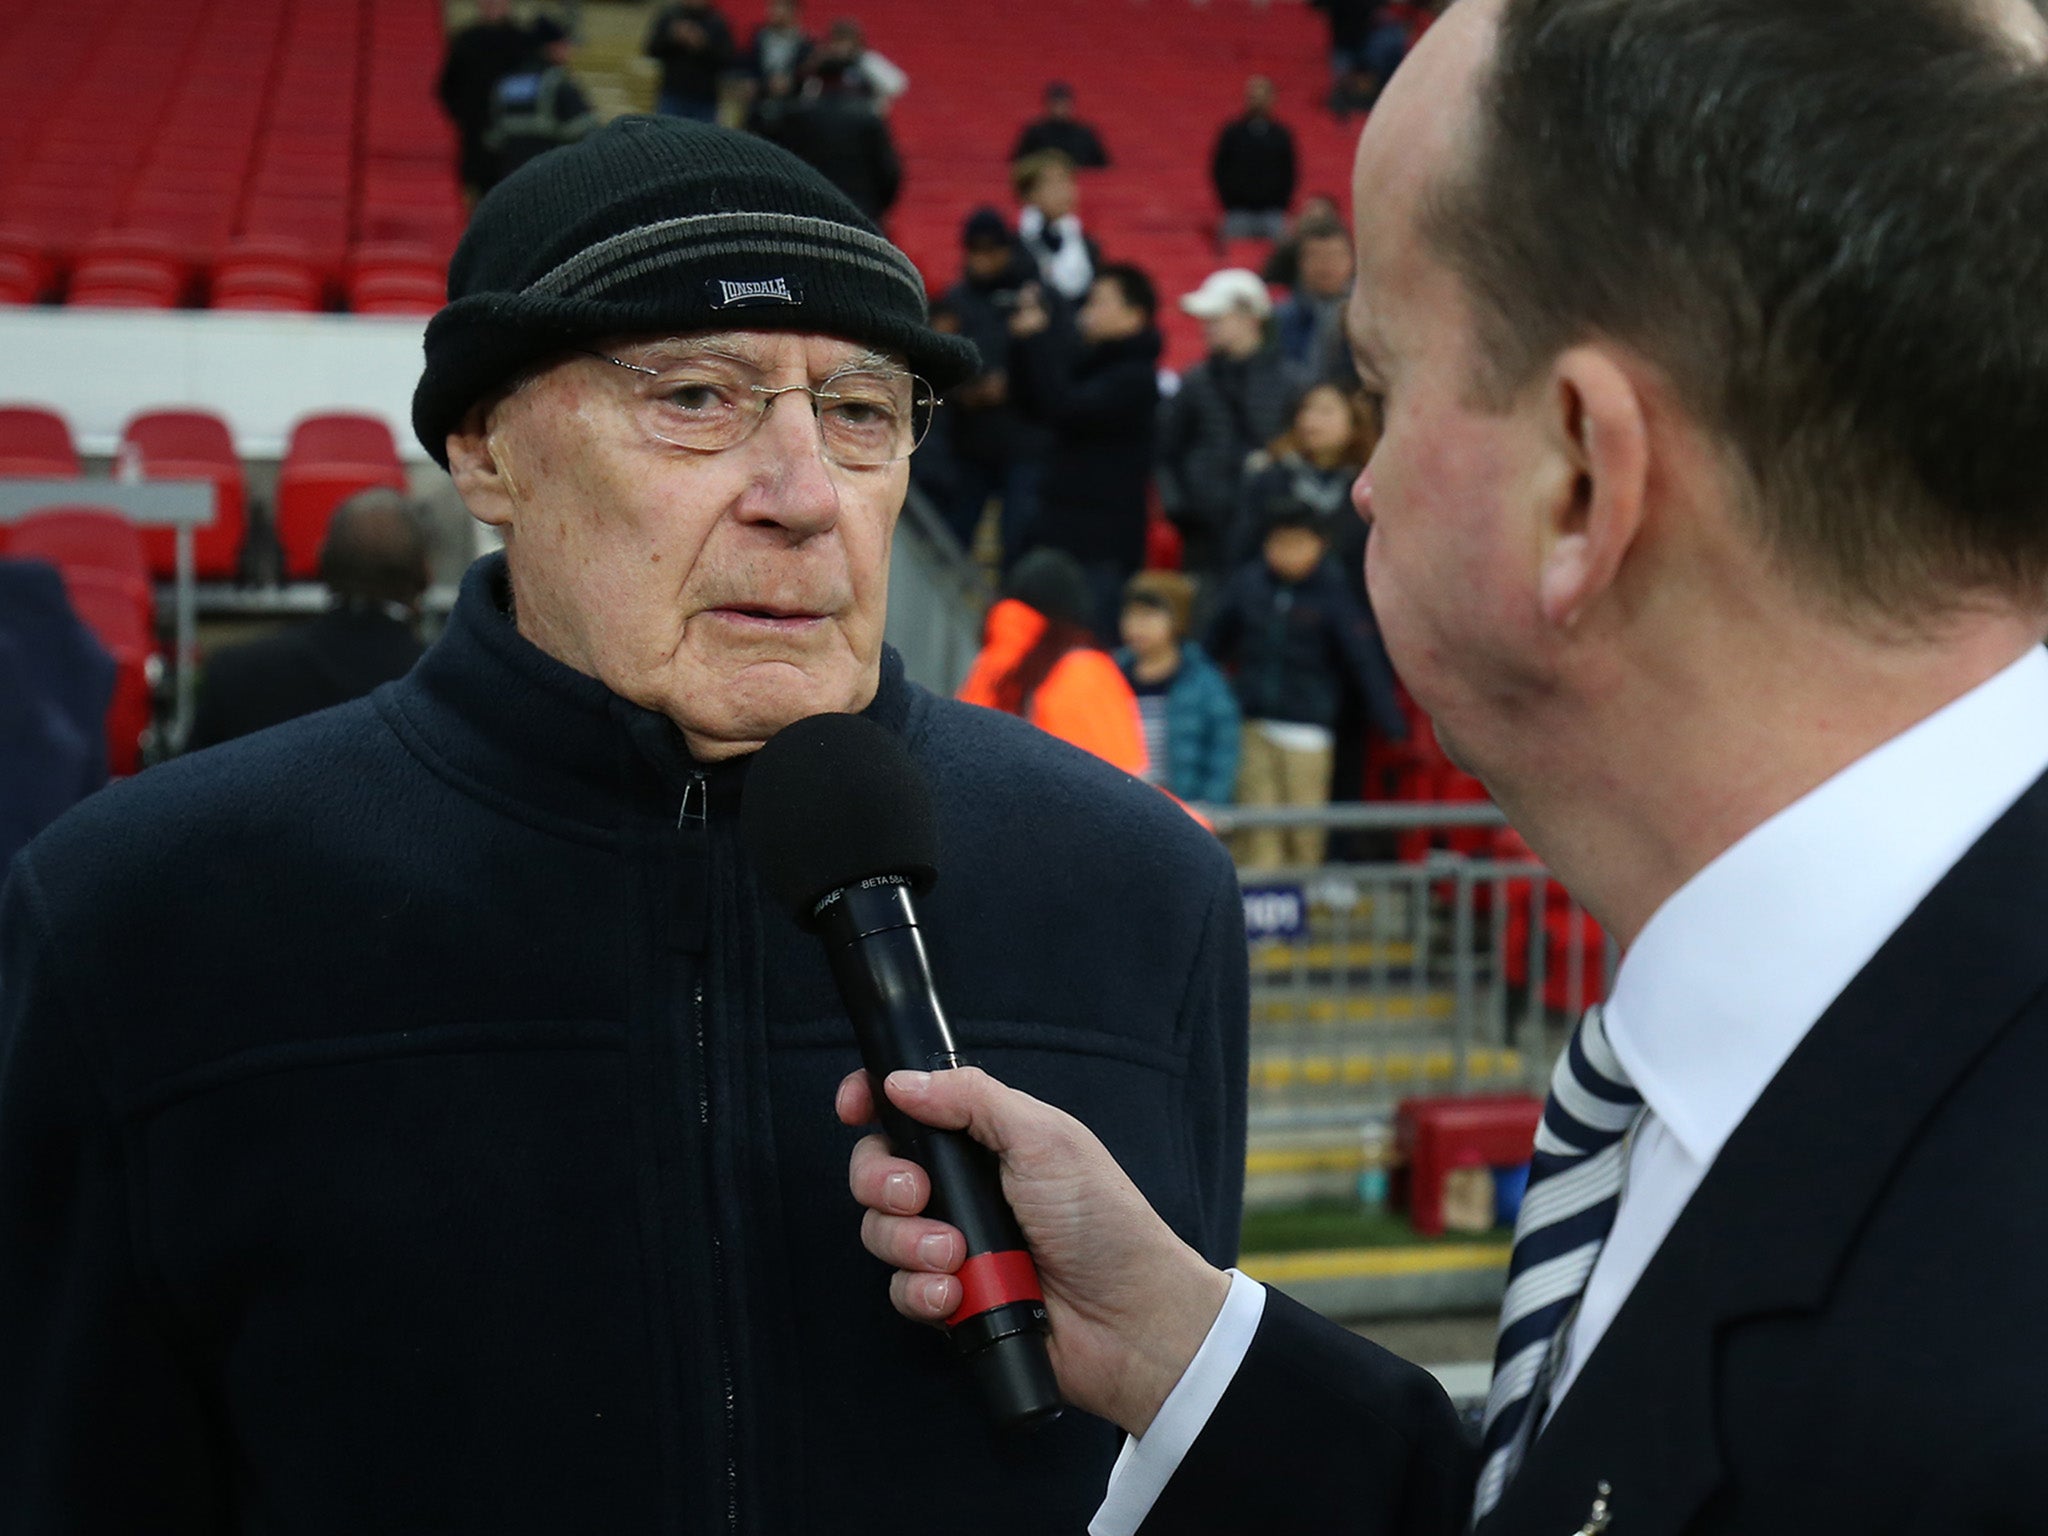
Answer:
[[1479, 778, 2048, 1536]]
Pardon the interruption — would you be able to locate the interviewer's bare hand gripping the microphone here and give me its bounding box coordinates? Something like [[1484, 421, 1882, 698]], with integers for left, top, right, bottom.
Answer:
[[838, 1067, 1231, 1434]]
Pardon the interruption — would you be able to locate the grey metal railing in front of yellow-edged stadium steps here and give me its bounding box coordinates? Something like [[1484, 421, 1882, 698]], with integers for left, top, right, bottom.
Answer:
[[1208, 805, 1614, 1206]]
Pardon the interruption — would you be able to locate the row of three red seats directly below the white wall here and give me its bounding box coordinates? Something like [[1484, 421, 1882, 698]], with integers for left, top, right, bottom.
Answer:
[[0, 406, 406, 580]]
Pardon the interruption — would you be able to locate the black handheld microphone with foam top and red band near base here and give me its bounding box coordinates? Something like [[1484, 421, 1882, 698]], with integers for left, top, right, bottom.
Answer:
[[739, 715, 1061, 1427]]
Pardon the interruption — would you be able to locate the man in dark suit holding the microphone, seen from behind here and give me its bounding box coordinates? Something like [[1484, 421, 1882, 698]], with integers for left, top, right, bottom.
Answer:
[[840, 0, 2048, 1536]]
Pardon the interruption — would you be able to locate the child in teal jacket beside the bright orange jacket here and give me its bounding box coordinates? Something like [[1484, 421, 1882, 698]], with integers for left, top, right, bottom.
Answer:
[[1116, 571, 1243, 805]]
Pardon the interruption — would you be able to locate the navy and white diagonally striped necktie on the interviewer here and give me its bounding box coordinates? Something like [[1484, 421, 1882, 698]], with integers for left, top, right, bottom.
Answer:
[[1473, 1006, 1642, 1524]]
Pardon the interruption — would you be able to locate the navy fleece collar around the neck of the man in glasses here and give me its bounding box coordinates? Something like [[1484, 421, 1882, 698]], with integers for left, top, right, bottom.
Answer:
[[381, 553, 911, 829]]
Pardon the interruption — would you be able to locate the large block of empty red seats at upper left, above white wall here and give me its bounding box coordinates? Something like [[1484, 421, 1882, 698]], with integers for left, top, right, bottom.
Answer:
[[0, 0, 463, 313]]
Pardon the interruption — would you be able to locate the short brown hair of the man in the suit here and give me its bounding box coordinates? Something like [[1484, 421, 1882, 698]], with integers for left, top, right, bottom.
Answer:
[[1425, 0, 2048, 627]]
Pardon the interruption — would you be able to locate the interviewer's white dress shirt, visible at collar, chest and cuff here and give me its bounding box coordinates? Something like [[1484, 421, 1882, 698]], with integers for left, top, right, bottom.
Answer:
[[1087, 649, 2048, 1536]]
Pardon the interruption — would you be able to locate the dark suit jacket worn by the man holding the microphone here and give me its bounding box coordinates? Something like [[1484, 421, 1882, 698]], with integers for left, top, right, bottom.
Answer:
[[1145, 780, 2048, 1536]]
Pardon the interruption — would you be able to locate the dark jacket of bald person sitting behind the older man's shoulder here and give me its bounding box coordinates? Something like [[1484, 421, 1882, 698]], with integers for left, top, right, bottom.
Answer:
[[190, 608, 422, 752]]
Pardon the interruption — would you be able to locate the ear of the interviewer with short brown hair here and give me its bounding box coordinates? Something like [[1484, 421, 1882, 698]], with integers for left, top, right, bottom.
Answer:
[[1538, 346, 1651, 629]]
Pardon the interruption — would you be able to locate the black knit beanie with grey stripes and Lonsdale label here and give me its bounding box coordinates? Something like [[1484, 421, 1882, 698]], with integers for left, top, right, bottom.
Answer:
[[412, 117, 977, 467]]
